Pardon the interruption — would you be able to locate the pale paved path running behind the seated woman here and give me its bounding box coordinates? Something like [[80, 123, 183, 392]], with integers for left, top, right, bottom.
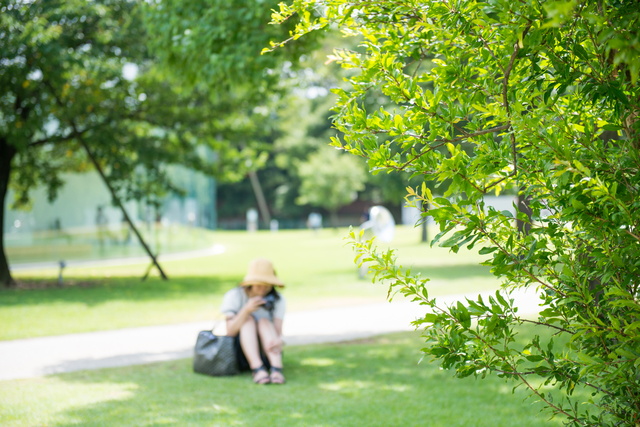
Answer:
[[0, 292, 539, 380]]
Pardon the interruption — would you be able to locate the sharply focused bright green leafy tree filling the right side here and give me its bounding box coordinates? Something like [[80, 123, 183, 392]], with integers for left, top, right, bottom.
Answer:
[[273, 0, 640, 426]]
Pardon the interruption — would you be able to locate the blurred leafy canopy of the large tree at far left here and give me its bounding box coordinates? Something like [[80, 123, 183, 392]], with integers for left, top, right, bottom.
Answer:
[[0, 0, 304, 286]]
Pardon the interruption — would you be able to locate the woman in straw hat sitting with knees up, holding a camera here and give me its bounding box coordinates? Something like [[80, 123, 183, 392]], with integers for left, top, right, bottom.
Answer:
[[220, 258, 285, 384]]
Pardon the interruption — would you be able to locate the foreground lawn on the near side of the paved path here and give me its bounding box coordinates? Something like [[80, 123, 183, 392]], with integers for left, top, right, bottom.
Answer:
[[0, 333, 561, 427]]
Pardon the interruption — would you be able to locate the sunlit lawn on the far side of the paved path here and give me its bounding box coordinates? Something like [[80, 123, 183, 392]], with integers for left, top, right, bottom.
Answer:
[[0, 227, 498, 340]]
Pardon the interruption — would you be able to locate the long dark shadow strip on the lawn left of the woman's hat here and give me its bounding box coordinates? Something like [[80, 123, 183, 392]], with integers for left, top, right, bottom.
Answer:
[[0, 277, 237, 308]]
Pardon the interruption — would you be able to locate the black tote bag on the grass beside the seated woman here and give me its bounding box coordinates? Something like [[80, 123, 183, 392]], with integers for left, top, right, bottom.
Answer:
[[193, 331, 239, 377]]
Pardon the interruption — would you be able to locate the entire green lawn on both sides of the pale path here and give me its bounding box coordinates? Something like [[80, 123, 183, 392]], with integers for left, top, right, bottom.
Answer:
[[0, 227, 584, 427]]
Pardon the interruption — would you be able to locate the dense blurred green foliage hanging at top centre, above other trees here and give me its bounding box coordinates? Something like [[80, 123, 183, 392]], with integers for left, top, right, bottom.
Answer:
[[144, 0, 319, 92]]
